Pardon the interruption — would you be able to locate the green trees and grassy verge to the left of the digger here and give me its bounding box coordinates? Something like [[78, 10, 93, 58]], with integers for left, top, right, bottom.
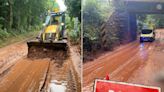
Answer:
[[0, 0, 48, 46]]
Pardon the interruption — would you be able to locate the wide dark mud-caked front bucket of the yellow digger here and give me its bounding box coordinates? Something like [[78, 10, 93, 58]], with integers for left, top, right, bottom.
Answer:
[[27, 40, 68, 59]]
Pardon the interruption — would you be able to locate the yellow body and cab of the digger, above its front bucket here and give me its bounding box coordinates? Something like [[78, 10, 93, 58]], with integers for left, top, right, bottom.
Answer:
[[42, 12, 65, 41]]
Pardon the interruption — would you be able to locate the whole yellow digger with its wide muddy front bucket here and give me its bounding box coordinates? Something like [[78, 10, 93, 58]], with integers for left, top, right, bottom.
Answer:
[[27, 12, 68, 58]]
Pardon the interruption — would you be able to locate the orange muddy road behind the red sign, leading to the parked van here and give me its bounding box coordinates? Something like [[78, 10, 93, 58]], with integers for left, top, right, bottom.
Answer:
[[83, 29, 164, 92]]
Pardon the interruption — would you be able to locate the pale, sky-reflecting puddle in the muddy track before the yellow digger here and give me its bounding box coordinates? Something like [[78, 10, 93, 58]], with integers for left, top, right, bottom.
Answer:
[[48, 80, 67, 92]]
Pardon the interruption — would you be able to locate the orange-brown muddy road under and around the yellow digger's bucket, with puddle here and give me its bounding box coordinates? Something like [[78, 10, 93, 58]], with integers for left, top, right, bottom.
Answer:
[[0, 42, 81, 92]]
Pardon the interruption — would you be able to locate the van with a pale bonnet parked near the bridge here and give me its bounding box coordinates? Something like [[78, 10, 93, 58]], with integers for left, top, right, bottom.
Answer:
[[140, 29, 155, 42]]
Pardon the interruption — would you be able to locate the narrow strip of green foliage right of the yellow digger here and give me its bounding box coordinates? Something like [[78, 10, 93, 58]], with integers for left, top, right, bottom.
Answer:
[[66, 0, 81, 44]]
